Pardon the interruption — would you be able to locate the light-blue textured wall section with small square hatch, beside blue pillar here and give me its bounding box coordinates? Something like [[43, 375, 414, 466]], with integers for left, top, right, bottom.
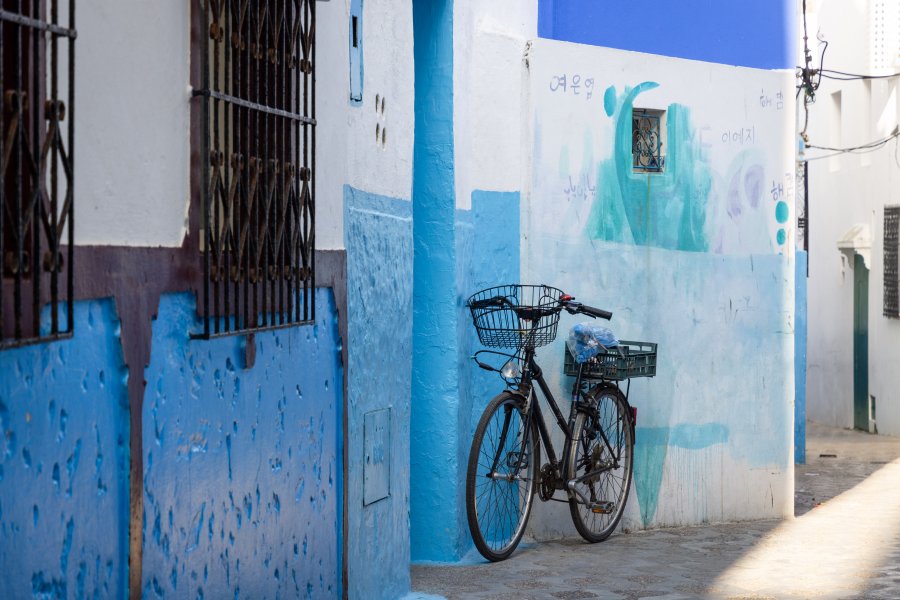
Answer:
[[344, 186, 413, 600]]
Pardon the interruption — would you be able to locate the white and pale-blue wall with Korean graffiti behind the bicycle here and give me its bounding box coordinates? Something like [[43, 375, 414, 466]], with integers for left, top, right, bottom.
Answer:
[[412, 1, 795, 560]]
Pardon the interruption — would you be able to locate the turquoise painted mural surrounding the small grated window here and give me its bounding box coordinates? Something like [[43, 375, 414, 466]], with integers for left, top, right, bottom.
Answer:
[[588, 81, 713, 252]]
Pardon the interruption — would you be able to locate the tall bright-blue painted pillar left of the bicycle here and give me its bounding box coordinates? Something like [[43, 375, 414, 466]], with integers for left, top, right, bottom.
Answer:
[[410, 0, 462, 560]]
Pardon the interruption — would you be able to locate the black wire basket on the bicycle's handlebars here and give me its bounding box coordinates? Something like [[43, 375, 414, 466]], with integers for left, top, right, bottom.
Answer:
[[466, 285, 563, 350]]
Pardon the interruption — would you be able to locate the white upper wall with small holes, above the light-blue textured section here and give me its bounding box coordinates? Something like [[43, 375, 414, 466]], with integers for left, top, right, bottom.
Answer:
[[316, 0, 415, 248]]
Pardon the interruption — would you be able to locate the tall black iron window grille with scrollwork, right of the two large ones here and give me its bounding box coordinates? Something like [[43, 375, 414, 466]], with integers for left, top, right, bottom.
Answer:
[[194, 0, 316, 338]]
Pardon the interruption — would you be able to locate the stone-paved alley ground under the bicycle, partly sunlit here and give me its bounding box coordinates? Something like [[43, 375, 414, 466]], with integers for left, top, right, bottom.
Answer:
[[410, 423, 900, 600]]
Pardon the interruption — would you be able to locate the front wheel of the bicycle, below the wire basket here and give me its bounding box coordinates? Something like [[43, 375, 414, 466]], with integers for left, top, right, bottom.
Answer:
[[466, 392, 540, 562]]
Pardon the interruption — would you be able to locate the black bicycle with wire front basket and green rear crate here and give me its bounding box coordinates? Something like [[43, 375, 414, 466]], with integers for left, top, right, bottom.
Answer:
[[465, 285, 656, 562]]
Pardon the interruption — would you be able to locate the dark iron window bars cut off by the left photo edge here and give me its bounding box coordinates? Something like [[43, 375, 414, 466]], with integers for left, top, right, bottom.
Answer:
[[0, 0, 77, 348]]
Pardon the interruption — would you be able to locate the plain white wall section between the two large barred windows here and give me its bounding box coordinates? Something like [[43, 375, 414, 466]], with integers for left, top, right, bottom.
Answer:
[[74, 0, 190, 246]]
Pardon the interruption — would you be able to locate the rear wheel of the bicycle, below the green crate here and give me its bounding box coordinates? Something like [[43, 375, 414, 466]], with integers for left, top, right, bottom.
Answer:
[[566, 385, 634, 543]]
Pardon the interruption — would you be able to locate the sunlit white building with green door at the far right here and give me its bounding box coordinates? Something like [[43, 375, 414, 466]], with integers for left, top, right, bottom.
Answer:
[[806, 0, 900, 435]]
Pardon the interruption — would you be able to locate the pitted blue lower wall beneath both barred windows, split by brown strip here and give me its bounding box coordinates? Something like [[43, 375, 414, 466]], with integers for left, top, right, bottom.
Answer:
[[0, 289, 343, 598]]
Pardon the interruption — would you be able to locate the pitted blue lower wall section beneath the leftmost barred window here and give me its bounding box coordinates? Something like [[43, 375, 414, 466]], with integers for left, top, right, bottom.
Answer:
[[0, 300, 129, 598]]
